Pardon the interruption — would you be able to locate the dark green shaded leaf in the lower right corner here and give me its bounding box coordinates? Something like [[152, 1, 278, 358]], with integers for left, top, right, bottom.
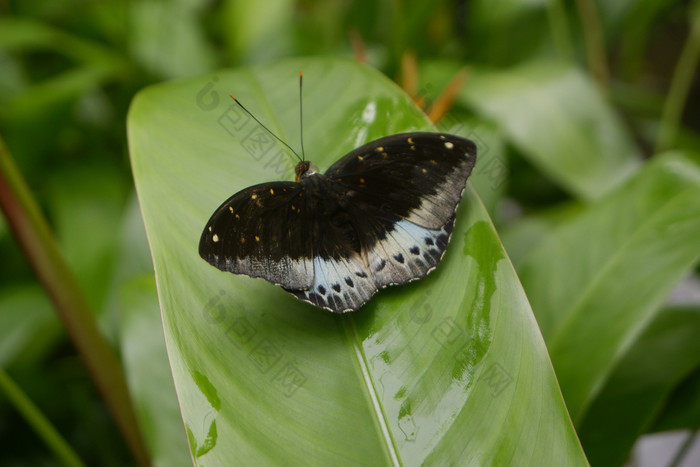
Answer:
[[578, 308, 700, 466]]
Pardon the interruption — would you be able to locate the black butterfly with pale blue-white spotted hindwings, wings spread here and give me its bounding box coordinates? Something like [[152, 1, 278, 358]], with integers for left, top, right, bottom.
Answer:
[[199, 133, 476, 313]]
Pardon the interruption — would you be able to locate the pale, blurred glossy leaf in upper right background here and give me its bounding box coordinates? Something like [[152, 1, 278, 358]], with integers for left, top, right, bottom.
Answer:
[[459, 61, 641, 200]]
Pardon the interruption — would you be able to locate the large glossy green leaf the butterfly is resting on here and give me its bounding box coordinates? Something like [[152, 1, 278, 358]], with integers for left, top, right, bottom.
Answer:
[[128, 59, 586, 465]]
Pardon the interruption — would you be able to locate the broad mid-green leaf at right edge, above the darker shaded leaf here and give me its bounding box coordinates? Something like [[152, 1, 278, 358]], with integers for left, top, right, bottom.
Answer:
[[519, 153, 700, 424]]
